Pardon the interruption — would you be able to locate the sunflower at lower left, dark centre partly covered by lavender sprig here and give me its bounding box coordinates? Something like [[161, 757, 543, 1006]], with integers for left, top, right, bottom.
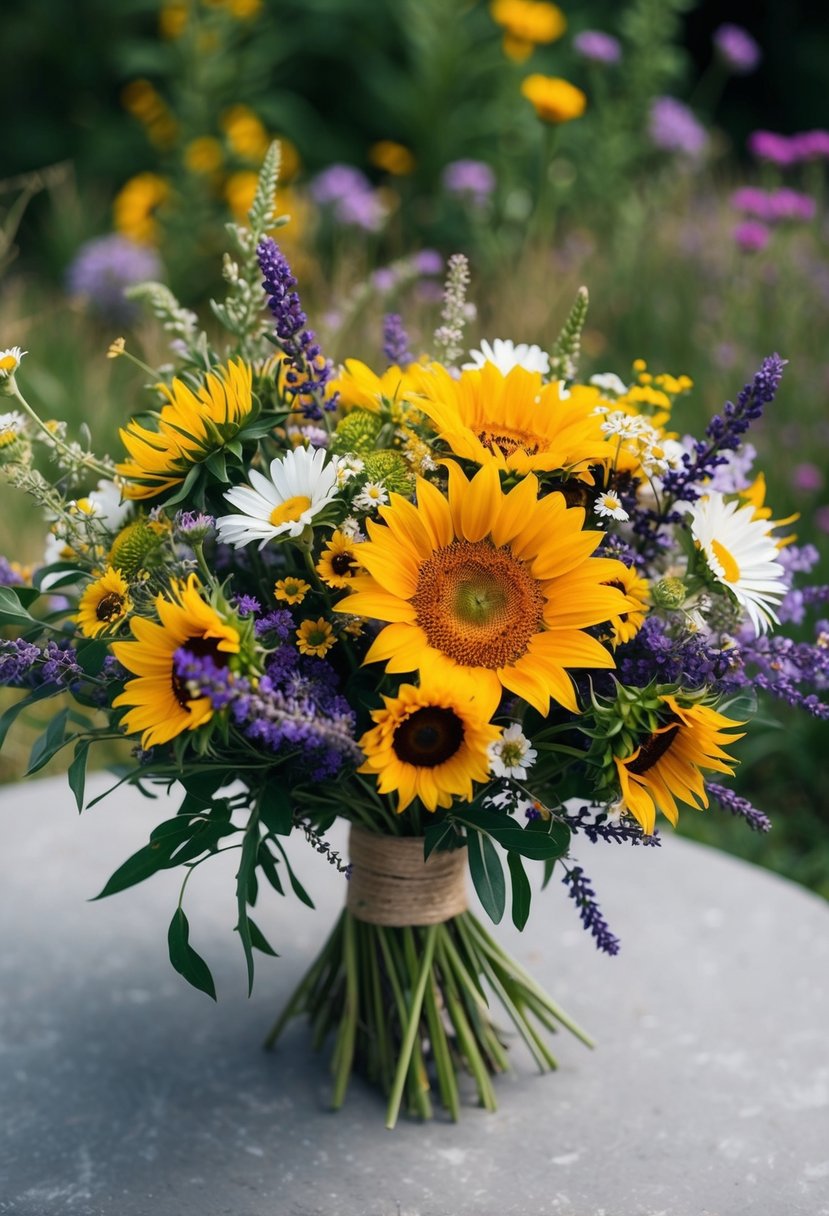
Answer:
[[112, 574, 239, 748]]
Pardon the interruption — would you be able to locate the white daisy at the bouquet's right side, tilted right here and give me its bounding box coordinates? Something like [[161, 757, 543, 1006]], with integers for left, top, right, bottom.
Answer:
[[688, 490, 788, 634]]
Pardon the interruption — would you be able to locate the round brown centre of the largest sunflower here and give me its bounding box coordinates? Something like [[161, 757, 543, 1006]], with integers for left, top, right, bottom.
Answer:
[[411, 540, 545, 670]]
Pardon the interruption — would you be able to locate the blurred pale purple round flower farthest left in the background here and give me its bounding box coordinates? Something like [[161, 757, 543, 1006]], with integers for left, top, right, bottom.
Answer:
[[66, 233, 163, 321]]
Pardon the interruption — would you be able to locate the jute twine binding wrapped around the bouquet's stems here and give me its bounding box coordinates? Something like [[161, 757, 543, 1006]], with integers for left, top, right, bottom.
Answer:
[[345, 824, 467, 925]]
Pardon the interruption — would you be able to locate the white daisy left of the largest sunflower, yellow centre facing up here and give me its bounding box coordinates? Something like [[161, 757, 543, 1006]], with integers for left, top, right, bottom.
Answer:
[[216, 447, 338, 548]]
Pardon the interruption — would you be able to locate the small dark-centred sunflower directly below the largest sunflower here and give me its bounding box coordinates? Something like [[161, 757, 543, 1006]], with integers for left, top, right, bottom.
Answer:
[[359, 679, 501, 812]]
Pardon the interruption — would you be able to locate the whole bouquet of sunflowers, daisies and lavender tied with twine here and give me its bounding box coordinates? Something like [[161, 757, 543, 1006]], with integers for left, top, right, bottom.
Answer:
[[0, 147, 829, 1126]]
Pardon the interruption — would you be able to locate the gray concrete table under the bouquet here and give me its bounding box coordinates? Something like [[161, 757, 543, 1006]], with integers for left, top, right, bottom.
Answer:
[[0, 778, 829, 1216]]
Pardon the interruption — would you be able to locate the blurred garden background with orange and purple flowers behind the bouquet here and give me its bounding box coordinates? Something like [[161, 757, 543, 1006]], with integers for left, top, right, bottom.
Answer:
[[0, 0, 829, 896]]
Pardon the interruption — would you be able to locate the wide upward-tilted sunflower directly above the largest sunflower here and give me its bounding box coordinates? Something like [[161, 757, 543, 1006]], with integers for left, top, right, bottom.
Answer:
[[417, 362, 613, 479]]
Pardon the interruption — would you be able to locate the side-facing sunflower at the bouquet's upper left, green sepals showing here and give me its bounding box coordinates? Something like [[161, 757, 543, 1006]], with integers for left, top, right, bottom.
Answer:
[[117, 359, 254, 499]]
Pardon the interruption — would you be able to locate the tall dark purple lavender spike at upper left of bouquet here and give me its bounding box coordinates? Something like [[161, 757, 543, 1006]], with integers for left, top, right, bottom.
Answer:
[[256, 236, 335, 420]]
